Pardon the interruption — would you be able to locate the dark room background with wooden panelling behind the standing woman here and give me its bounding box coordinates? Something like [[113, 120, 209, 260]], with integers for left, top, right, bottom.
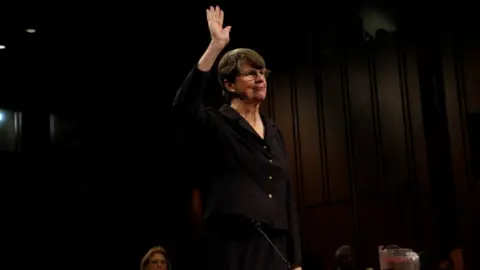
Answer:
[[0, 0, 480, 269]]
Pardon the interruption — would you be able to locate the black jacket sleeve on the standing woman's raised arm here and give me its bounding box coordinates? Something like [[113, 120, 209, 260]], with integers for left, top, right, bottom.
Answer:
[[173, 64, 210, 121]]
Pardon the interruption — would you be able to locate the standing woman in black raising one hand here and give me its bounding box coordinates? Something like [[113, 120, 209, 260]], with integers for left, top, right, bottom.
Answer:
[[174, 6, 301, 270]]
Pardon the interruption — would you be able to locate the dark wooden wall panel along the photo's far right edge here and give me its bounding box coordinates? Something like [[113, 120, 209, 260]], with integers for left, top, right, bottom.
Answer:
[[442, 36, 480, 269]]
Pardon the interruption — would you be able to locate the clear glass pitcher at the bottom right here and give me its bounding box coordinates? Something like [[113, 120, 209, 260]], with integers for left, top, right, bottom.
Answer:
[[378, 246, 420, 270]]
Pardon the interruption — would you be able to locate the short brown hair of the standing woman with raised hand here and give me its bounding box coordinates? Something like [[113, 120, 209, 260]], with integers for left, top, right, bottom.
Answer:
[[217, 48, 266, 102]]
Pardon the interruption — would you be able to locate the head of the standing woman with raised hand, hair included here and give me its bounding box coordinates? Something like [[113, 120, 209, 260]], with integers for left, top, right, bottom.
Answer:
[[218, 48, 269, 103]]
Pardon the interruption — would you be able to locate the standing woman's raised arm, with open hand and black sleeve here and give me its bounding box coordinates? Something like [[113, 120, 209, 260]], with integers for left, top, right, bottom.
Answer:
[[173, 6, 231, 118]]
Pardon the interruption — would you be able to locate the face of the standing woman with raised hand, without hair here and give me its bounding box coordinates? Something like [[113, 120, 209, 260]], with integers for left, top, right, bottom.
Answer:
[[226, 63, 268, 102]]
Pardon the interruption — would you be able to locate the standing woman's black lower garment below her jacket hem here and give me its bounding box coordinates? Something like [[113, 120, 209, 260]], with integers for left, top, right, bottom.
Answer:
[[196, 216, 288, 270]]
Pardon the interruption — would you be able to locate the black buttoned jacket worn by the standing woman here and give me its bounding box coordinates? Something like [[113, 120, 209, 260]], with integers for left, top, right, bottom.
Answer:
[[173, 65, 301, 265]]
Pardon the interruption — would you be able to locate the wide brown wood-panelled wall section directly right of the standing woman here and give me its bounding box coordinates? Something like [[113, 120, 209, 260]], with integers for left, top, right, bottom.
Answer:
[[270, 39, 433, 267]]
